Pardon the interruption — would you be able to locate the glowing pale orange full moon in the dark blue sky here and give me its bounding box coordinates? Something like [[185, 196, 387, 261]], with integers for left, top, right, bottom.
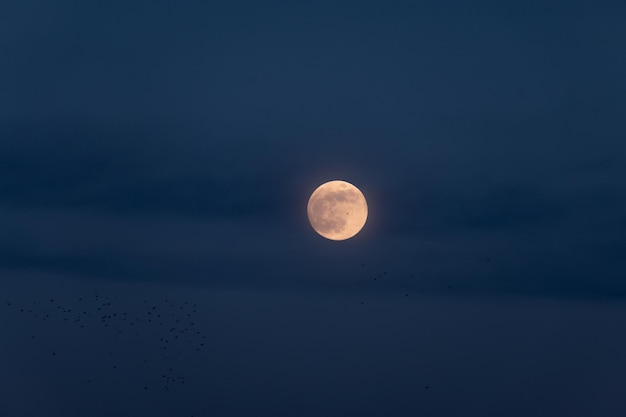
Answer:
[[307, 181, 367, 240]]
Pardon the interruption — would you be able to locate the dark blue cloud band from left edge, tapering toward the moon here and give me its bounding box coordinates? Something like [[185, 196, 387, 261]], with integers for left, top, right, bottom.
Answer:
[[0, 119, 292, 217]]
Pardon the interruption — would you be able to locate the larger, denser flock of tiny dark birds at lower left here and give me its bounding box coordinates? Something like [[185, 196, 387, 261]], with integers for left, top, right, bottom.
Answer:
[[4, 291, 207, 391]]
